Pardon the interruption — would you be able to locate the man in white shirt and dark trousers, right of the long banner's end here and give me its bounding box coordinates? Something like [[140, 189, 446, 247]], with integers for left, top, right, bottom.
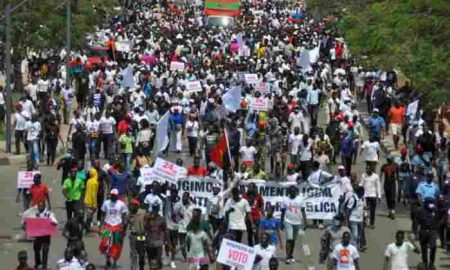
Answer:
[[360, 166, 381, 228]]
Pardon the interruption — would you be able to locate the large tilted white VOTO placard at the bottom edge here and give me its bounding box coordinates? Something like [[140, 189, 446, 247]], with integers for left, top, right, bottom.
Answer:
[[217, 239, 256, 270]]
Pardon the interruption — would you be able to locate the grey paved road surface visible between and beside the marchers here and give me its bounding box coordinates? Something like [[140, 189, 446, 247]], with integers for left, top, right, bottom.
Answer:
[[0, 106, 450, 270]]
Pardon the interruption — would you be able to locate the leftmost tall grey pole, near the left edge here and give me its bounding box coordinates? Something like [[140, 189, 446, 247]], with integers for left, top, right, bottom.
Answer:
[[5, 4, 12, 153]]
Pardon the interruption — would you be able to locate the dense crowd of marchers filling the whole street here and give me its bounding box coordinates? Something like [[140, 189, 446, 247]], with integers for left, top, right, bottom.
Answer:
[[8, 0, 450, 270]]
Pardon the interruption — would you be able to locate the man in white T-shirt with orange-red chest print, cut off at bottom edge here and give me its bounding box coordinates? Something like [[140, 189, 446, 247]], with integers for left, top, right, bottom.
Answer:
[[328, 232, 361, 270]]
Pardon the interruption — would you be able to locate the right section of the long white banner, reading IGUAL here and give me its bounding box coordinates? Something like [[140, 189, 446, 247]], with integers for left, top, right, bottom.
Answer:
[[240, 180, 341, 220]]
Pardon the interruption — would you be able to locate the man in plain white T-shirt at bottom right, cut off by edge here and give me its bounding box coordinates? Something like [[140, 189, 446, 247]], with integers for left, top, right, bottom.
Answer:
[[383, 231, 420, 270]]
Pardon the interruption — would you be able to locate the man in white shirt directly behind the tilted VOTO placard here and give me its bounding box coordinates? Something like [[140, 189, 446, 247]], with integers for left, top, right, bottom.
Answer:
[[225, 187, 253, 242]]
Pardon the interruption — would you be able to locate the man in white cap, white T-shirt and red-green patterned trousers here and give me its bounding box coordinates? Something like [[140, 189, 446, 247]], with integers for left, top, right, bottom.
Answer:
[[99, 188, 128, 268]]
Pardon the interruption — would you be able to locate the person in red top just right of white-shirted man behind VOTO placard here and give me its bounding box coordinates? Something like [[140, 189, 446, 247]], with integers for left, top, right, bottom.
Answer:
[[242, 183, 264, 246]]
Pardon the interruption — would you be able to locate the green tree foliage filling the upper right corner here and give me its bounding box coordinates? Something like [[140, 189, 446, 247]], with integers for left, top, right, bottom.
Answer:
[[308, 0, 450, 105]]
